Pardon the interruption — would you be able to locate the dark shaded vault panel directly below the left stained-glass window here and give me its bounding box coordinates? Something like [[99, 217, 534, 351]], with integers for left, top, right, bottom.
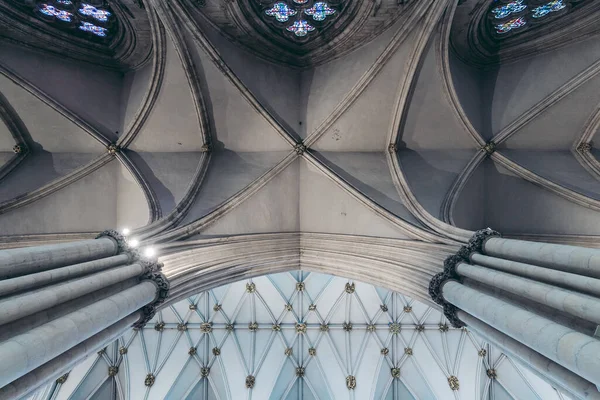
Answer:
[[0, 42, 123, 134]]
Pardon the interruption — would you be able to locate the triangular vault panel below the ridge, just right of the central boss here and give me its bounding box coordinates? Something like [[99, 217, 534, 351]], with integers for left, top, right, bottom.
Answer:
[[317, 152, 420, 226]]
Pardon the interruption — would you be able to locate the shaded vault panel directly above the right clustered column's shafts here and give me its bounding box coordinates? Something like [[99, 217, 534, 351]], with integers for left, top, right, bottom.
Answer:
[[484, 163, 600, 235]]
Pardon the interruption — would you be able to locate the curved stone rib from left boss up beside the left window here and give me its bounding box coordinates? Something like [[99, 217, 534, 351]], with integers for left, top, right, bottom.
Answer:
[[117, 8, 167, 147]]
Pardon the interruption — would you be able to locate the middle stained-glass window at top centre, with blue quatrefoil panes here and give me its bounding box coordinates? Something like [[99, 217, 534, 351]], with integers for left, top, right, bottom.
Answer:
[[261, 0, 342, 39]]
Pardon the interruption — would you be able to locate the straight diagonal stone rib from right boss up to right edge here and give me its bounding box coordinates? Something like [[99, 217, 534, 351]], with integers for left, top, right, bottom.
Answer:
[[492, 60, 600, 145]]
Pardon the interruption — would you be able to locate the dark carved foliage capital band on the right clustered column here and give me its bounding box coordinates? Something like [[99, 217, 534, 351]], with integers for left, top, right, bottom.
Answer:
[[429, 228, 501, 328]]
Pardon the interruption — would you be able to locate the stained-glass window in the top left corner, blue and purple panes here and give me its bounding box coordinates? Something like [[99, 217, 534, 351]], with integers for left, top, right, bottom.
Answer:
[[12, 0, 116, 40]]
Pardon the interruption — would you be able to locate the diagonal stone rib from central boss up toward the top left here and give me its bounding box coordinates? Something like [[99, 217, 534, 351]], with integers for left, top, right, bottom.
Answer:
[[166, 1, 296, 147]]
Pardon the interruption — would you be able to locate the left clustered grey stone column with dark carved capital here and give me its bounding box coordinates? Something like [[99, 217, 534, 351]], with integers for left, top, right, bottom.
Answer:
[[0, 231, 169, 399]]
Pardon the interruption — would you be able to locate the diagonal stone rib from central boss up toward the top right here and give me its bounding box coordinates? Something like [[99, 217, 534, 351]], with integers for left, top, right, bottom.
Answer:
[[304, 2, 430, 147]]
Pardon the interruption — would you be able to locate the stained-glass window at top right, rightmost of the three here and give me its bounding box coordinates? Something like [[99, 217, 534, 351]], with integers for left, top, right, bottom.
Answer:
[[488, 0, 584, 39]]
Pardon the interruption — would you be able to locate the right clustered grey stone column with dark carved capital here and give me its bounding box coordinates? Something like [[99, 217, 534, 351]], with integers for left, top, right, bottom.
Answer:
[[429, 228, 600, 399]]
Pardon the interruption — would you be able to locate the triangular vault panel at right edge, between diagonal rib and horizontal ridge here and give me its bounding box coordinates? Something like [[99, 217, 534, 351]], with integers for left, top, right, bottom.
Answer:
[[502, 75, 600, 150]]
